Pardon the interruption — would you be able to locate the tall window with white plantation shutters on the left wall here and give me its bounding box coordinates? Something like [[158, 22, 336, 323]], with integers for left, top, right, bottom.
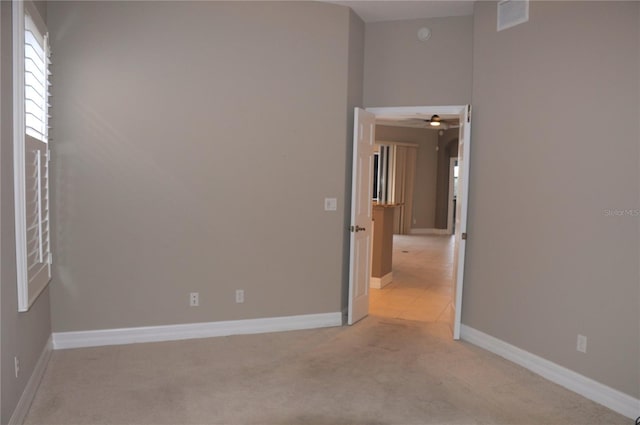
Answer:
[[13, 1, 52, 311]]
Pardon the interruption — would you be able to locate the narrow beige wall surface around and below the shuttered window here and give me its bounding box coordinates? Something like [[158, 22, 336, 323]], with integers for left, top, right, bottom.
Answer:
[[0, 1, 51, 424]]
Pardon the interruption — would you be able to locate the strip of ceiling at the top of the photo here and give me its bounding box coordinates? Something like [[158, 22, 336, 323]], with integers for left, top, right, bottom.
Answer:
[[327, 0, 474, 23]]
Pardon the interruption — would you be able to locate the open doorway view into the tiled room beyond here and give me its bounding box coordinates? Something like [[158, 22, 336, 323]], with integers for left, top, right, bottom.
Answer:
[[369, 124, 459, 329]]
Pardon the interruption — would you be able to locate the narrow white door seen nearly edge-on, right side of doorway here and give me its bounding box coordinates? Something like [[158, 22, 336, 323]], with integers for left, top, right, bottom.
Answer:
[[452, 105, 471, 339]]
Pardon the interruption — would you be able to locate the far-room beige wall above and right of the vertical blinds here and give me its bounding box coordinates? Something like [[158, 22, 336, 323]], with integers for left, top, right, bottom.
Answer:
[[376, 125, 438, 229]]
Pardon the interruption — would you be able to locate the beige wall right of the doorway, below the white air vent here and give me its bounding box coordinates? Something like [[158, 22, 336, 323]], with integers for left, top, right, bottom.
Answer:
[[462, 2, 640, 397]]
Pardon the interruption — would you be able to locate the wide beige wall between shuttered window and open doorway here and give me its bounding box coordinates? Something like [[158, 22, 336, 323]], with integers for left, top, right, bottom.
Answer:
[[49, 2, 362, 331]]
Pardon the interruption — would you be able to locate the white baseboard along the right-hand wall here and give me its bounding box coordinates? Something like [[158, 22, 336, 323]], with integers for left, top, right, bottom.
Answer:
[[461, 325, 640, 419]]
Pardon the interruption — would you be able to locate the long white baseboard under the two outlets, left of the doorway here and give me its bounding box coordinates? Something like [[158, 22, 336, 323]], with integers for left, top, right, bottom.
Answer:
[[53, 312, 342, 350]]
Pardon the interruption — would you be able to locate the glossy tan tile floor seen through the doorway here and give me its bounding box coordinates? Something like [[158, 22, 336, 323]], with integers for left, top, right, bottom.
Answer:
[[369, 235, 454, 323]]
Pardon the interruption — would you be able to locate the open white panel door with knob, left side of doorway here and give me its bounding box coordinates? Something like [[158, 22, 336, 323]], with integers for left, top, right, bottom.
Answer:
[[347, 108, 376, 325]]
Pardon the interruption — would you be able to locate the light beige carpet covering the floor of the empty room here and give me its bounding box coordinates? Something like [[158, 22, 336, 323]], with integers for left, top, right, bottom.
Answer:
[[26, 317, 632, 425]]
